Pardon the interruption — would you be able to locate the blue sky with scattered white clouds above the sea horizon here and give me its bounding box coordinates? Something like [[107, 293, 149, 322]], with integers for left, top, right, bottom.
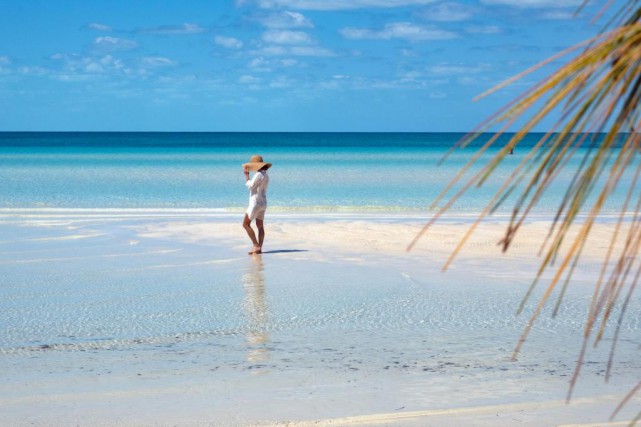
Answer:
[[0, 0, 616, 131]]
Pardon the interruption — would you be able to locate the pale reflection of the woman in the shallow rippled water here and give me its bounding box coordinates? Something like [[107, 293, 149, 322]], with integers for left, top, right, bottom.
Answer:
[[243, 257, 269, 362]]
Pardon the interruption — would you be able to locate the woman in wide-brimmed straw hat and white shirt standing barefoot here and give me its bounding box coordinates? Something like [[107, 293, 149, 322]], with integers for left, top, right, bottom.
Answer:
[[243, 156, 272, 255]]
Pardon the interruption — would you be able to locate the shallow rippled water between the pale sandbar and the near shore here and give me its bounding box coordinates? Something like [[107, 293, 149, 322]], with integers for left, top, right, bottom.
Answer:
[[0, 216, 641, 355]]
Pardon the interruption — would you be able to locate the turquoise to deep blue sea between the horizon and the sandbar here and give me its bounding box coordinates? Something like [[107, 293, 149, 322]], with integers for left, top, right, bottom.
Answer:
[[0, 132, 628, 214]]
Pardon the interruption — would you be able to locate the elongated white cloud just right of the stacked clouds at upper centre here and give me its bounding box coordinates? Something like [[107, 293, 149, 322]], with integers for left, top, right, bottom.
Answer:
[[339, 22, 457, 41]]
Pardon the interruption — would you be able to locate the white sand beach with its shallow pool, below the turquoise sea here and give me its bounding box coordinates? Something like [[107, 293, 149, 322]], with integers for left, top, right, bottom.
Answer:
[[0, 210, 641, 426]]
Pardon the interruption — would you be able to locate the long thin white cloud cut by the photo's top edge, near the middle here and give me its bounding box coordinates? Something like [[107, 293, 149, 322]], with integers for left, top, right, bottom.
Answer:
[[250, 0, 435, 10]]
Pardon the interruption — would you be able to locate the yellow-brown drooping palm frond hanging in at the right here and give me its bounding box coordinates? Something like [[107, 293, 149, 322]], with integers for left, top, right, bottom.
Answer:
[[407, 0, 641, 414]]
